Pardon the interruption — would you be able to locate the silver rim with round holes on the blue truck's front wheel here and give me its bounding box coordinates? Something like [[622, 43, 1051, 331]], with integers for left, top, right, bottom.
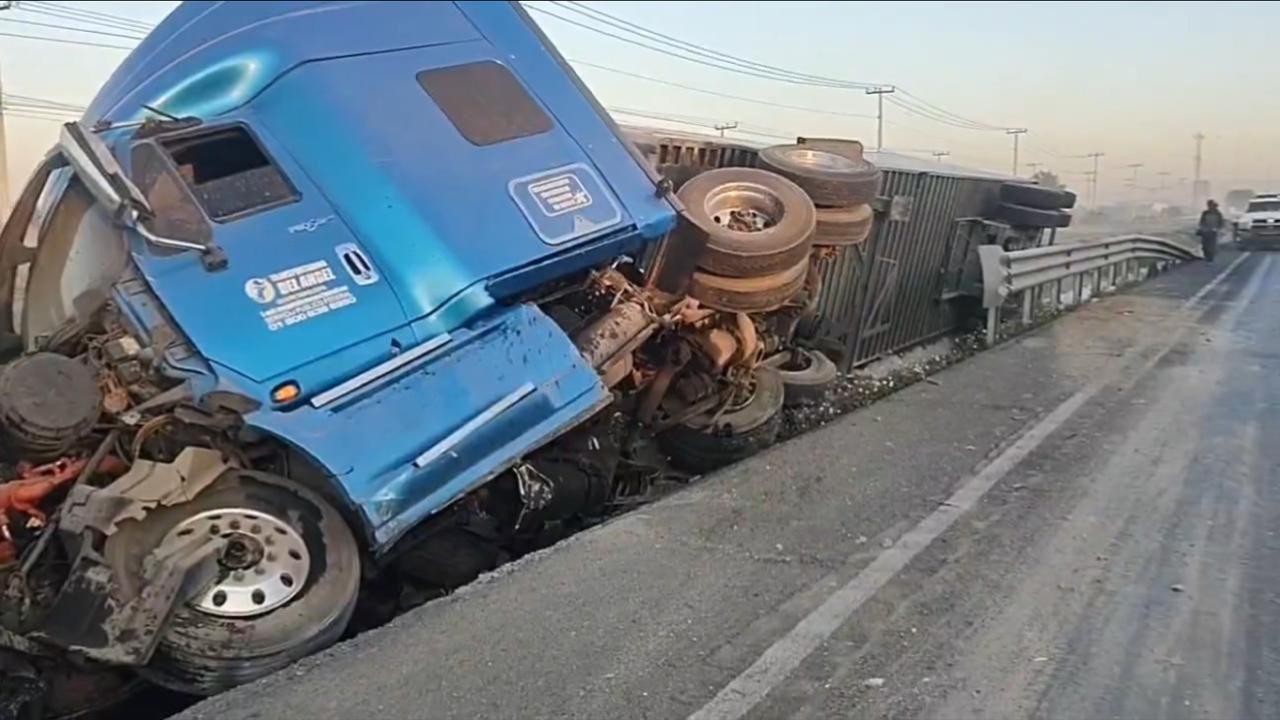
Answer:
[[161, 507, 311, 618]]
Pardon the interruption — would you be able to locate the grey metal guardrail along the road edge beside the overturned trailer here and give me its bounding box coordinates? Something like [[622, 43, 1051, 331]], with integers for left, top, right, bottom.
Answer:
[[968, 234, 1199, 345]]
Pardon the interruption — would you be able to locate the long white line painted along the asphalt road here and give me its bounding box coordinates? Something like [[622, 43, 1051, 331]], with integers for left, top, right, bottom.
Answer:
[[689, 252, 1271, 720]]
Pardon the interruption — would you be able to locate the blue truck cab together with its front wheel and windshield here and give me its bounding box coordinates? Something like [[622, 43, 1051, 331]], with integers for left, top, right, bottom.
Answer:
[[0, 1, 677, 693]]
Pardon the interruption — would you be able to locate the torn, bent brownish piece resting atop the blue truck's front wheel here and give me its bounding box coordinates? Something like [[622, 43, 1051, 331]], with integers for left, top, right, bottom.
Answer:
[[61, 447, 232, 541]]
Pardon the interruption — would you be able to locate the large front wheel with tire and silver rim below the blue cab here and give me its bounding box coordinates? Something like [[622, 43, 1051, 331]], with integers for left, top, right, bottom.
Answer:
[[105, 470, 360, 696]]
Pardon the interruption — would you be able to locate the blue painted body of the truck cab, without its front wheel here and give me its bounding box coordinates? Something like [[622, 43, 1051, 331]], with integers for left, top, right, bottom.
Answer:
[[73, 3, 675, 550]]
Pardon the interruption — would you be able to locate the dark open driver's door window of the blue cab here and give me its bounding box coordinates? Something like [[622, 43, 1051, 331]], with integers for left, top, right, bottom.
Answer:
[[159, 126, 298, 222]]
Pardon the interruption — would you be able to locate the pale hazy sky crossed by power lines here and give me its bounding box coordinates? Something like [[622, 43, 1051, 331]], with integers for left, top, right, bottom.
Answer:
[[0, 0, 1280, 202]]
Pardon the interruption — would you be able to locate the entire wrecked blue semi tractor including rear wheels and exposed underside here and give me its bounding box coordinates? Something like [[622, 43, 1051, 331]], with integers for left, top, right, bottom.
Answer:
[[0, 3, 901, 717]]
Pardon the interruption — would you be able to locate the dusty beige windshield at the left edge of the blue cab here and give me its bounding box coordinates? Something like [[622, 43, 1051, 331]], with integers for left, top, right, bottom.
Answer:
[[14, 168, 127, 350]]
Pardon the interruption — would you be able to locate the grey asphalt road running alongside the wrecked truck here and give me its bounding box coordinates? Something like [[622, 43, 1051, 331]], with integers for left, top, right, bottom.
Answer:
[[188, 252, 1280, 720]]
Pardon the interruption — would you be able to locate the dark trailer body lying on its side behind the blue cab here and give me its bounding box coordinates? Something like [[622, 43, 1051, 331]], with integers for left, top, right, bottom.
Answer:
[[623, 126, 1075, 370]]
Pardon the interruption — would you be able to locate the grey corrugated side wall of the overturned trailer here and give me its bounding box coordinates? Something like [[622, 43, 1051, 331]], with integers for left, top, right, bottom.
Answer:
[[637, 133, 1001, 370]]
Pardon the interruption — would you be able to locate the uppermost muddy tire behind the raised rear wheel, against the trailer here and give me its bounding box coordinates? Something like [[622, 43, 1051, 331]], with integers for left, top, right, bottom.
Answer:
[[756, 145, 881, 208]]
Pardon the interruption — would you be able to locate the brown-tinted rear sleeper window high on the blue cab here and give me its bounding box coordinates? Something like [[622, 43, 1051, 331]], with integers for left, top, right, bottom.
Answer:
[[417, 60, 552, 146]]
